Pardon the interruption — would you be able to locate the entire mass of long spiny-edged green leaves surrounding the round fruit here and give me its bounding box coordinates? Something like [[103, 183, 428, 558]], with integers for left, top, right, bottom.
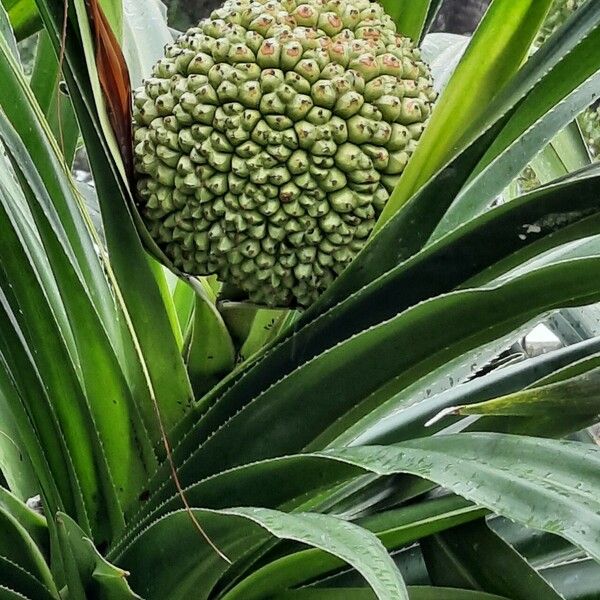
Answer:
[[0, 0, 600, 600]]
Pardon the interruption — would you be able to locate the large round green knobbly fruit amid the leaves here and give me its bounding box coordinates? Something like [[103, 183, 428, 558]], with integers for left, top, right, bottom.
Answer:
[[134, 0, 435, 306]]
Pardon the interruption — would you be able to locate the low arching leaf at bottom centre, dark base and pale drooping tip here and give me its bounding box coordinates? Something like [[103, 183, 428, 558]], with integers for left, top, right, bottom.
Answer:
[[120, 508, 408, 600]]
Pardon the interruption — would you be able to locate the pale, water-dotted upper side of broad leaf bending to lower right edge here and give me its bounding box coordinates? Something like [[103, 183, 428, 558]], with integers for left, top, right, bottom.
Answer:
[[324, 433, 600, 560]]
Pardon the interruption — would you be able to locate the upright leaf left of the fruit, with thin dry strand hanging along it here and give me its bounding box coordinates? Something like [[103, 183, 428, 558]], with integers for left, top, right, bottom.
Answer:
[[32, 0, 192, 442]]
